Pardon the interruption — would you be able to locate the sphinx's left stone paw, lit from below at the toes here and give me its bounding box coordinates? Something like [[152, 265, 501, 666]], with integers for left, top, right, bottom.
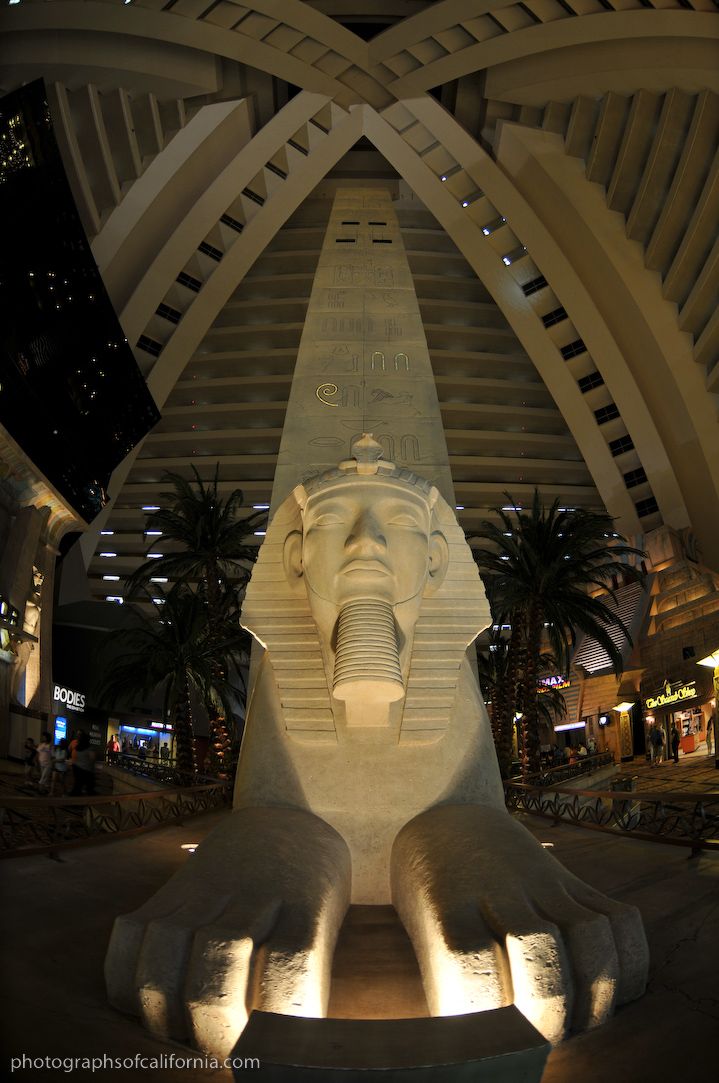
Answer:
[[105, 808, 350, 1056]]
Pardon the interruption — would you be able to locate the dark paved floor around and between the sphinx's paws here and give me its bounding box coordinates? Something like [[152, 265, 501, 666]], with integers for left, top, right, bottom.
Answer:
[[0, 792, 719, 1083]]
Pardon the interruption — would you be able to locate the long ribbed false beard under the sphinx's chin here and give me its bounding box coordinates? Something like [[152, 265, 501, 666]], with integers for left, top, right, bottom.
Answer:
[[332, 599, 404, 726]]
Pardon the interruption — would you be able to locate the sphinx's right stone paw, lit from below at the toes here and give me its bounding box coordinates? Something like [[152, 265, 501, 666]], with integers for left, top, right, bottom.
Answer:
[[392, 806, 649, 1042]]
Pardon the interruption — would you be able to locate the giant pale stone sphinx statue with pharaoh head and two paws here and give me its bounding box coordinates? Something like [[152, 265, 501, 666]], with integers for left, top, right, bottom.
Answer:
[[106, 436, 648, 1056]]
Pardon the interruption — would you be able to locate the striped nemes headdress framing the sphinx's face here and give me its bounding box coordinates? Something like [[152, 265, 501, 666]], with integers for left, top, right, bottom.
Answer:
[[241, 433, 491, 744]]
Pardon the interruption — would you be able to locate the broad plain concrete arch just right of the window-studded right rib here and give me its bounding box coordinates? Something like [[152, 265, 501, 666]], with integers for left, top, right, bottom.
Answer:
[[497, 125, 719, 560]]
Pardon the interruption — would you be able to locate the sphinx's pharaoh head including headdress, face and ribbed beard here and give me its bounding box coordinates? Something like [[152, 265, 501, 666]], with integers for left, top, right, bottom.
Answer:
[[243, 434, 488, 733]]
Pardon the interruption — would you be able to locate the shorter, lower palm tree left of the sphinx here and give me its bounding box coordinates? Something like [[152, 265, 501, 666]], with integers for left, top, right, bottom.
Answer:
[[97, 586, 245, 774]]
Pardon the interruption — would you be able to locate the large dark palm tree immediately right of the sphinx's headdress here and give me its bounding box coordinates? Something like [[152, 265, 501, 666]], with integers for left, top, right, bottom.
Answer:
[[475, 490, 643, 777]]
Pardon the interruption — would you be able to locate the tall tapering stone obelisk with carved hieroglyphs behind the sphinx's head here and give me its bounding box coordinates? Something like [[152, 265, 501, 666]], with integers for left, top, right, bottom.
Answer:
[[272, 188, 454, 510]]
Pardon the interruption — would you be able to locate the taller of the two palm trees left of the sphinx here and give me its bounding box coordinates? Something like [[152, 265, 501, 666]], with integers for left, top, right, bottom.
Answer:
[[128, 464, 266, 770]]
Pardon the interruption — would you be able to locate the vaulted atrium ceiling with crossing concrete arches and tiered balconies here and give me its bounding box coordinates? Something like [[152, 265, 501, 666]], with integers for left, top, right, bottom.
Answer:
[[0, 0, 719, 598]]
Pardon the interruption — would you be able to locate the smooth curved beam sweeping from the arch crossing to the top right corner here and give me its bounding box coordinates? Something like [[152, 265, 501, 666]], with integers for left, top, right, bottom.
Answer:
[[388, 9, 719, 99]]
